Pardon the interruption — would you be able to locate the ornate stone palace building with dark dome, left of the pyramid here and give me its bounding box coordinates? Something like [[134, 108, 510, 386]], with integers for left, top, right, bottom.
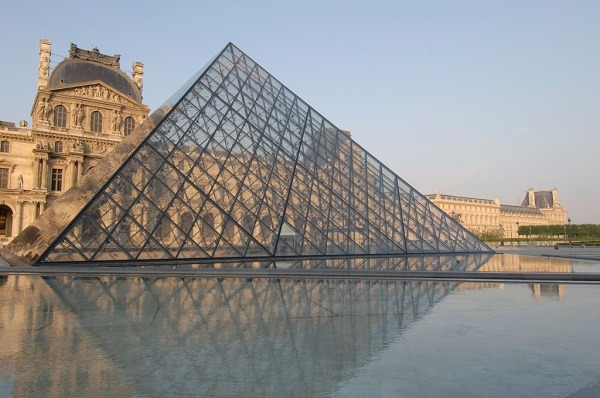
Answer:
[[0, 40, 149, 247]]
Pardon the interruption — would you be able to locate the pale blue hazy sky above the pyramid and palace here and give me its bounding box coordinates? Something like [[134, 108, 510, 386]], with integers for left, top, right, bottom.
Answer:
[[0, 0, 600, 224]]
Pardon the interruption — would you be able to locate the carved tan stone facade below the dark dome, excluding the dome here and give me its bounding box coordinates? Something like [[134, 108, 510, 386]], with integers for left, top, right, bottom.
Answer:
[[0, 40, 149, 247]]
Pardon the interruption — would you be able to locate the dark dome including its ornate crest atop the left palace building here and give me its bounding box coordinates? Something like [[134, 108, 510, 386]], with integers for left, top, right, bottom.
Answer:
[[48, 44, 142, 103]]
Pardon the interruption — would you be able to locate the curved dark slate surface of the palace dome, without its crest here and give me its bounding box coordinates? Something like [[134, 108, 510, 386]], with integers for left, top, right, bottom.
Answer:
[[48, 52, 142, 103]]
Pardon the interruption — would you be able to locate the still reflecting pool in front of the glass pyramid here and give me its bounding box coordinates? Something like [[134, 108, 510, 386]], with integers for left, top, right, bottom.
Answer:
[[0, 257, 600, 397]]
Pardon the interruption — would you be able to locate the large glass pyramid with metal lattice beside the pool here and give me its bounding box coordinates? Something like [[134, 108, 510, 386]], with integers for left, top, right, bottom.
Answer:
[[7, 43, 491, 263]]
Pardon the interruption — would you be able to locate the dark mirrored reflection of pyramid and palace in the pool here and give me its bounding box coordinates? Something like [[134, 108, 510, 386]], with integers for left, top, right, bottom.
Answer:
[[0, 256, 572, 397]]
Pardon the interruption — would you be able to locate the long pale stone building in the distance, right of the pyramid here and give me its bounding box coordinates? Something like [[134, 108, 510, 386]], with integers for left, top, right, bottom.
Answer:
[[426, 188, 567, 238]]
